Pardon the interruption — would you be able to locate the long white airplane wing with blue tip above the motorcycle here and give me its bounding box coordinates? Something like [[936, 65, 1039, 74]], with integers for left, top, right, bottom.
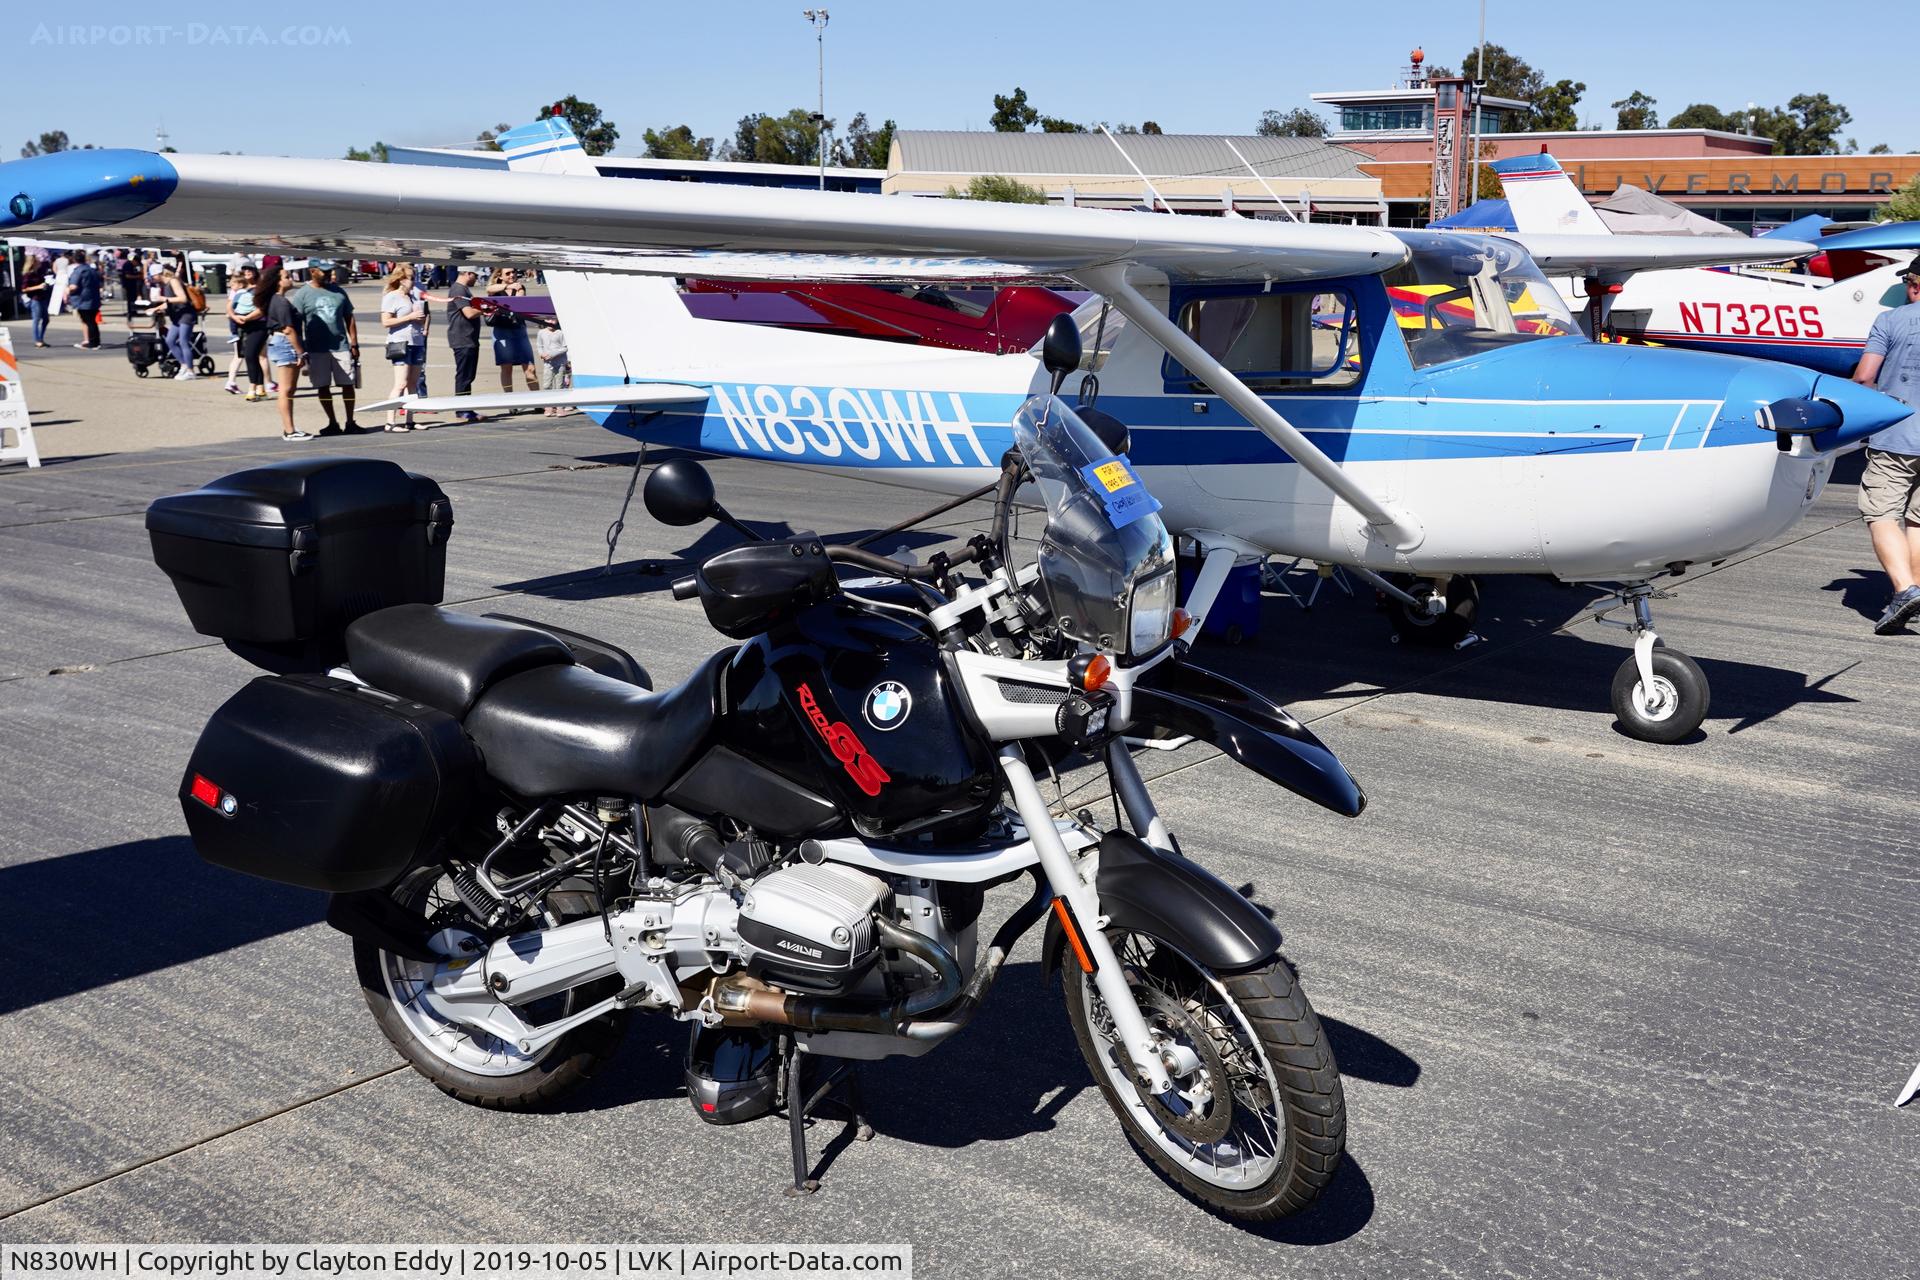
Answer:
[[0, 150, 1407, 280]]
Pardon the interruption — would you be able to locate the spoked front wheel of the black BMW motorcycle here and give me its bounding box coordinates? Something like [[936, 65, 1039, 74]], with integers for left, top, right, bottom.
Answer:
[[1066, 929, 1346, 1221]]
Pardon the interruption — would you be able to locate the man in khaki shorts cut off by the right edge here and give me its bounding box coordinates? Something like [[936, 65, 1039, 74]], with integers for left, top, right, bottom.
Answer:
[[1853, 257, 1920, 635]]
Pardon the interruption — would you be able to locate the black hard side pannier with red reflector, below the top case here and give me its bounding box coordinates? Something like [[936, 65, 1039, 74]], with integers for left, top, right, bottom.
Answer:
[[180, 676, 480, 892]]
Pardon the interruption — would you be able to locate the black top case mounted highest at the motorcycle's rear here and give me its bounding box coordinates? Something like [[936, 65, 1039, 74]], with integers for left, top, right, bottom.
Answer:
[[146, 459, 453, 672]]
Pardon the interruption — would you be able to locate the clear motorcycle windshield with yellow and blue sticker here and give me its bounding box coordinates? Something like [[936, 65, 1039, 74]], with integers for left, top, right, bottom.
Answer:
[[1014, 395, 1173, 654]]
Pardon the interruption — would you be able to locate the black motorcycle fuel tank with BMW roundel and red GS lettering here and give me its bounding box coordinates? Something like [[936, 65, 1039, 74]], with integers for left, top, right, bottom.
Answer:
[[718, 603, 1000, 841]]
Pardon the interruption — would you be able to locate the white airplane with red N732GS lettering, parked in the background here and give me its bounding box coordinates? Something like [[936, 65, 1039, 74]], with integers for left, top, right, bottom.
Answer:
[[1492, 154, 1920, 376]]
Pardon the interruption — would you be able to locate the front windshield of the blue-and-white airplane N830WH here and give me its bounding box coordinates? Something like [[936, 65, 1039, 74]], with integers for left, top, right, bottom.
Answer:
[[1382, 232, 1580, 368]]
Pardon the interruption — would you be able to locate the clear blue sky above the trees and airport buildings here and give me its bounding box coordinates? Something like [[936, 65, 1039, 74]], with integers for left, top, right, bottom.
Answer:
[[11, 0, 1920, 159]]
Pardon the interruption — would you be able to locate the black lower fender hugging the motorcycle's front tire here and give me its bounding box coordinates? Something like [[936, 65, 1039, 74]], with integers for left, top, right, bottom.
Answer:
[[1041, 831, 1281, 975]]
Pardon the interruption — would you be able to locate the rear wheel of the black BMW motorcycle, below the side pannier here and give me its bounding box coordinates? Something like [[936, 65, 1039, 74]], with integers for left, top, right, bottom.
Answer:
[[353, 867, 626, 1111]]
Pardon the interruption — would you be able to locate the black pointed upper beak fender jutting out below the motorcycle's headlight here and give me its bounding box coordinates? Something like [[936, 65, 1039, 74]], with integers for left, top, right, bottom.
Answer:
[[1125, 662, 1367, 818]]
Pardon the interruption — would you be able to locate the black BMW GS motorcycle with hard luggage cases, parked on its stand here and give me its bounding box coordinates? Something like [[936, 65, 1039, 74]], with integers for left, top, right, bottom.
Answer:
[[148, 322, 1363, 1219]]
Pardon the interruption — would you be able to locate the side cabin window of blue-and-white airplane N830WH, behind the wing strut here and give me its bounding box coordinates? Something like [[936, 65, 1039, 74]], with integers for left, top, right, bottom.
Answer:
[[1169, 290, 1361, 391]]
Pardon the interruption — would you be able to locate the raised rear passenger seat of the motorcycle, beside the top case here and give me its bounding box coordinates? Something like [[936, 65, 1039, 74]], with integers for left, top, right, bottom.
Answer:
[[348, 604, 574, 718]]
